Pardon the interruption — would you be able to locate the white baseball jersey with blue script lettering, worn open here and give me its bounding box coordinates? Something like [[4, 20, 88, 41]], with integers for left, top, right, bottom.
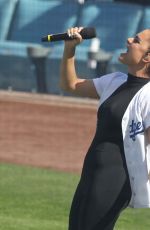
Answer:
[[93, 72, 150, 208]]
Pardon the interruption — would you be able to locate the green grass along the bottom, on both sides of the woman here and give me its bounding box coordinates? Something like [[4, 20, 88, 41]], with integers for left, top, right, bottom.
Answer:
[[0, 164, 150, 230]]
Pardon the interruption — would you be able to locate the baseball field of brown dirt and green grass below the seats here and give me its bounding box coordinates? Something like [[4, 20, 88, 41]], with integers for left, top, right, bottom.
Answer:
[[0, 91, 150, 230]]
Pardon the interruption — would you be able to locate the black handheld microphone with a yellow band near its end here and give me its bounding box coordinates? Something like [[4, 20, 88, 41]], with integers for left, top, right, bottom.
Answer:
[[42, 27, 96, 42]]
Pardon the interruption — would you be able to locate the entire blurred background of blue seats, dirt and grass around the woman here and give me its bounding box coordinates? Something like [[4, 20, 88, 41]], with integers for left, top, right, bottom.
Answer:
[[0, 0, 150, 230]]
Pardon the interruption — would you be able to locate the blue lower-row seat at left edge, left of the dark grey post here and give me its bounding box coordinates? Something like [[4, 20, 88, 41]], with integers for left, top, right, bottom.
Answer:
[[0, 41, 41, 92]]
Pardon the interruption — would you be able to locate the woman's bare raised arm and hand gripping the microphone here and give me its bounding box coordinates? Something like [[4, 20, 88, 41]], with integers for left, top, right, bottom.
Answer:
[[60, 27, 99, 99]]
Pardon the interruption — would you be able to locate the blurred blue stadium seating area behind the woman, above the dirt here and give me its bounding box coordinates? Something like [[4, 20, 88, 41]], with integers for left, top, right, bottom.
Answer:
[[0, 0, 150, 95]]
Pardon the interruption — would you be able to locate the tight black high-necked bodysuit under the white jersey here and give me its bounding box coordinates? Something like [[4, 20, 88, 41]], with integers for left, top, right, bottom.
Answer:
[[69, 74, 149, 230]]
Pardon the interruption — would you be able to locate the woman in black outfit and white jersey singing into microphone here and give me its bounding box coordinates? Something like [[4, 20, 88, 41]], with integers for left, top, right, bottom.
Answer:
[[60, 27, 150, 230]]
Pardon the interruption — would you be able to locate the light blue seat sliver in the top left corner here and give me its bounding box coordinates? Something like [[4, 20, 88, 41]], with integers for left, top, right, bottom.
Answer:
[[0, 0, 18, 40]]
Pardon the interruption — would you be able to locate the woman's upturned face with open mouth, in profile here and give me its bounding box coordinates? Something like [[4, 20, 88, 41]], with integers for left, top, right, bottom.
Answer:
[[119, 30, 150, 68]]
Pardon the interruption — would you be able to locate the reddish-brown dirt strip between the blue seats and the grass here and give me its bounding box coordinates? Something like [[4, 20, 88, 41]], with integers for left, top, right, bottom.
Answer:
[[0, 91, 98, 172]]
